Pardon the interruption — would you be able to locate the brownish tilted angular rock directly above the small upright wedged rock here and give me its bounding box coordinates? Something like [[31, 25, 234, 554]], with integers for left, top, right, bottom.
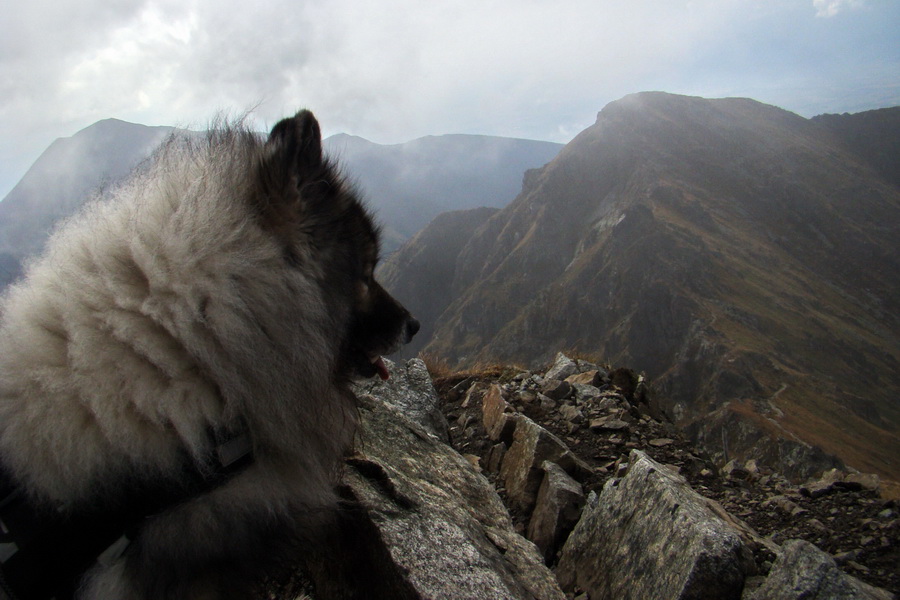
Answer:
[[500, 415, 590, 513]]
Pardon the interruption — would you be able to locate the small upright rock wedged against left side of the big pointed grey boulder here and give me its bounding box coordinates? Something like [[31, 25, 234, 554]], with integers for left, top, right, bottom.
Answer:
[[526, 461, 584, 565]]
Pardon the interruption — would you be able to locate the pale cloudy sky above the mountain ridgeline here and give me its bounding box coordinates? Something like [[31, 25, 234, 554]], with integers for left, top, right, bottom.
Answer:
[[0, 0, 900, 198]]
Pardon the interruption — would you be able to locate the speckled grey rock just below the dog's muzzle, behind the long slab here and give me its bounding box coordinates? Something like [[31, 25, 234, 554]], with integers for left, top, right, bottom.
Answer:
[[355, 358, 450, 442]]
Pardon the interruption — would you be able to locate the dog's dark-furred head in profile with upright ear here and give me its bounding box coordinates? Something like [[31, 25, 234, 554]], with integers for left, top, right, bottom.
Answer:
[[256, 111, 419, 379]]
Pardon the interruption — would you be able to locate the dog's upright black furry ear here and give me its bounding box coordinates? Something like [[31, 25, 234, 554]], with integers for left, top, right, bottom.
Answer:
[[258, 110, 327, 223]]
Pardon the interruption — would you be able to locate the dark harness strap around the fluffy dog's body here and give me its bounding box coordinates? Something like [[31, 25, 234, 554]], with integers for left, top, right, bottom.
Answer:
[[0, 431, 253, 600]]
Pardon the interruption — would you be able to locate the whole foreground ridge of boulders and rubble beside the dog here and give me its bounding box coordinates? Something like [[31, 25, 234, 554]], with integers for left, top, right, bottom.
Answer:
[[268, 356, 900, 600]]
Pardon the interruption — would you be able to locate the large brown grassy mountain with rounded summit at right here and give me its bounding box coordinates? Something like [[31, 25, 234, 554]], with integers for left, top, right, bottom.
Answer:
[[381, 93, 900, 480]]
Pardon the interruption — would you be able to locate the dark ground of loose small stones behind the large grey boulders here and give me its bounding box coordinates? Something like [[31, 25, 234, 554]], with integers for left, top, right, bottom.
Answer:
[[436, 355, 900, 598]]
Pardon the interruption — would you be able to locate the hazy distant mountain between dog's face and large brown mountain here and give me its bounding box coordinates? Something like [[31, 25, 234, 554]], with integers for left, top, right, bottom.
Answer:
[[324, 134, 563, 254]]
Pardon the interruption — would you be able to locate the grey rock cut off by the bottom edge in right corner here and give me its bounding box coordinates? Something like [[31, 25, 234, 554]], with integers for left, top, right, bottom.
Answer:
[[745, 540, 892, 600]]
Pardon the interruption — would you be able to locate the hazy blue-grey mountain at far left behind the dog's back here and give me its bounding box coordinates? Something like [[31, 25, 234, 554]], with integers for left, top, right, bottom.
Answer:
[[0, 119, 172, 287]]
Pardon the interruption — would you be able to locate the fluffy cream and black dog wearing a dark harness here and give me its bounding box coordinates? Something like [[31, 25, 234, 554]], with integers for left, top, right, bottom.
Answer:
[[0, 111, 419, 600]]
